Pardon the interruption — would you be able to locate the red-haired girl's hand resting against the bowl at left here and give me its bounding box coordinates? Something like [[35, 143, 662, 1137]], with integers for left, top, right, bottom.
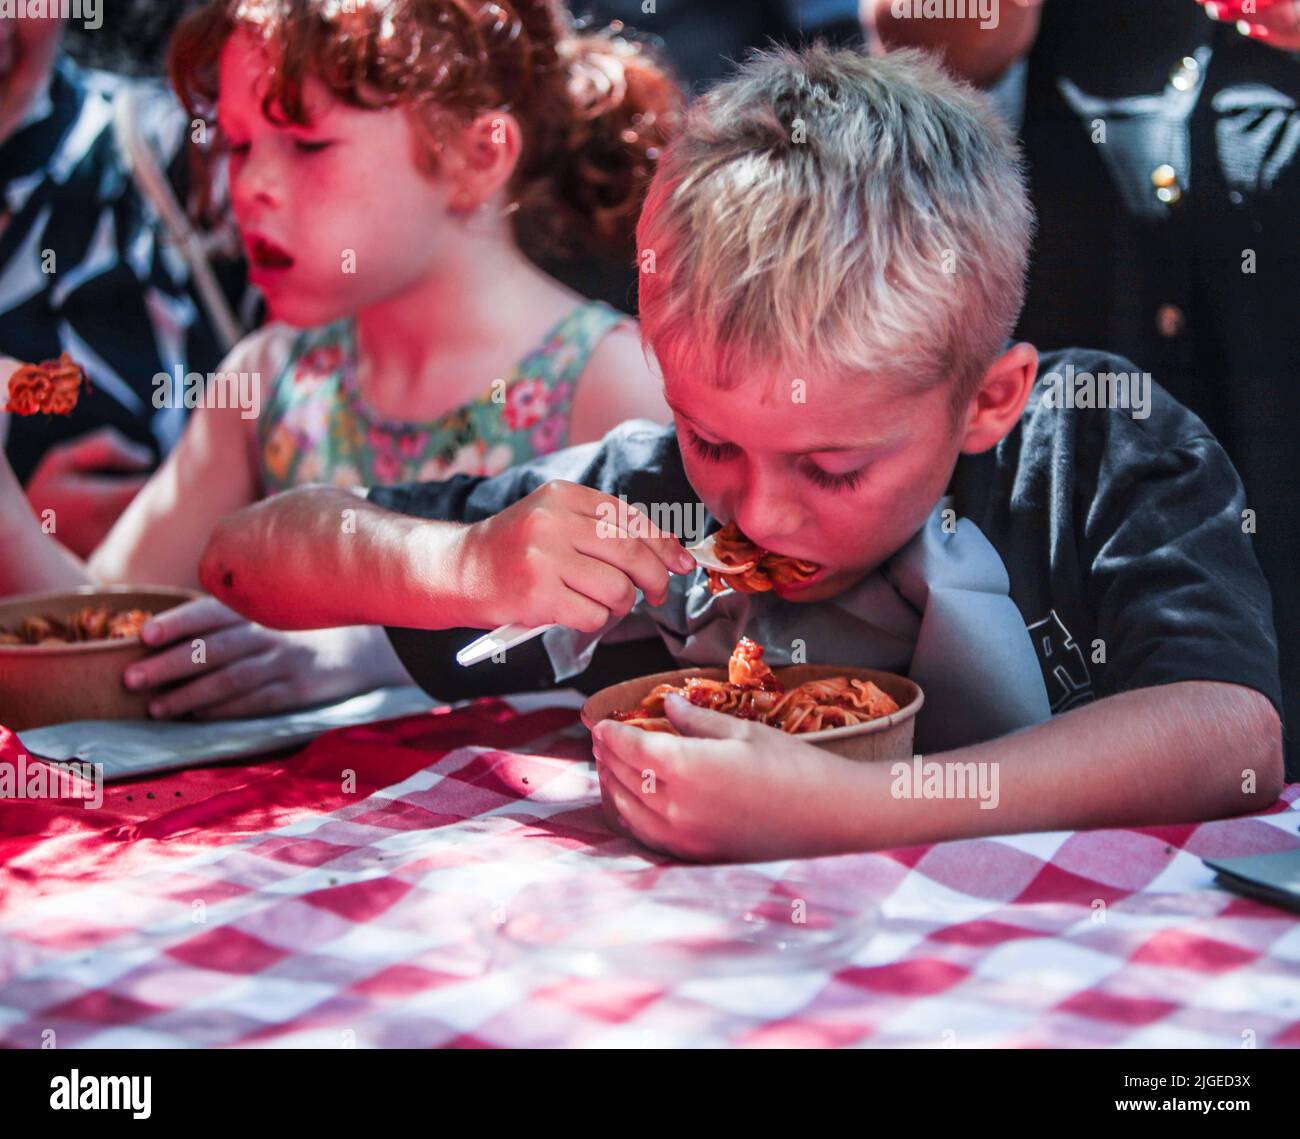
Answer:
[[124, 597, 385, 720]]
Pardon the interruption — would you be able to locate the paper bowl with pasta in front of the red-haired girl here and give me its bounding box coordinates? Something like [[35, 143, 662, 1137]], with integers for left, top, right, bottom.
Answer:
[[0, 585, 199, 731]]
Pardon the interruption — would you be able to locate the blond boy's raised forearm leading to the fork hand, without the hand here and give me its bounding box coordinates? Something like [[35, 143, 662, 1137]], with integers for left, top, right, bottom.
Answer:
[[199, 486, 467, 629]]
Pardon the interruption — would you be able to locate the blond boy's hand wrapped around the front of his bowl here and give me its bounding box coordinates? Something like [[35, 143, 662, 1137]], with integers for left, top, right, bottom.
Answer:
[[592, 696, 870, 862]]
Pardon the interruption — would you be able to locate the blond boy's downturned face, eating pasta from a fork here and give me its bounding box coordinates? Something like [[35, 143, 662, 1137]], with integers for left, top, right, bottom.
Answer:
[[664, 376, 963, 602]]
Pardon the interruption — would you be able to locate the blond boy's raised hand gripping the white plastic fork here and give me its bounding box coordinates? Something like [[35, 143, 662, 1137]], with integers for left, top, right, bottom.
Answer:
[[454, 481, 696, 632]]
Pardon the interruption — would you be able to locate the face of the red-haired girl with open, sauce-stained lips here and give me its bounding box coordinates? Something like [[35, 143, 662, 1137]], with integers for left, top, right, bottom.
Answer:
[[217, 31, 462, 326]]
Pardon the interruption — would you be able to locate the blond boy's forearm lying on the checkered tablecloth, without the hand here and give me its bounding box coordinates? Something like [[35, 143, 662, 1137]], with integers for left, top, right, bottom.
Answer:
[[852, 681, 1283, 849]]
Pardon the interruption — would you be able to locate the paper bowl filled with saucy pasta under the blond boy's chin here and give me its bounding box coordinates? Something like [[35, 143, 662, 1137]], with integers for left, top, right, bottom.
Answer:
[[581, 637, 926, 759]]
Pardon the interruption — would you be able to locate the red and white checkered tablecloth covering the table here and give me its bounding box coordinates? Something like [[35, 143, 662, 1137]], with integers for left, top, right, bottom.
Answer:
[[0, 701, 1300, 1048]]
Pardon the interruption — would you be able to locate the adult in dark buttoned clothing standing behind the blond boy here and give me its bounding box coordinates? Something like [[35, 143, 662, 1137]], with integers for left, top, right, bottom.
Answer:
[[863, 0, 1300, 765]]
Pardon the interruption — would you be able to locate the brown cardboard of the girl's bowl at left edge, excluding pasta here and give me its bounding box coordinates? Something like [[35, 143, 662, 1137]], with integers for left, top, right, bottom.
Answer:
[[0, 585, 199, 732]]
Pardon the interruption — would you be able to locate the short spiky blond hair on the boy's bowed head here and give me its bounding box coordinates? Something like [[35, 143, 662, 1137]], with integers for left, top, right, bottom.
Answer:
[[637, 44, 1034, 412]]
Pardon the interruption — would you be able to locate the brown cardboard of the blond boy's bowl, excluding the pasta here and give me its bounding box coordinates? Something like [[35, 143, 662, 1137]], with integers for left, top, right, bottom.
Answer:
[[581, 664, 926, 832]]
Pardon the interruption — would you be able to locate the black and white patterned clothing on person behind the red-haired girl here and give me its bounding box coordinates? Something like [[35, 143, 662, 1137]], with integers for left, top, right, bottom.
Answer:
[[0, 56, 241, 480]]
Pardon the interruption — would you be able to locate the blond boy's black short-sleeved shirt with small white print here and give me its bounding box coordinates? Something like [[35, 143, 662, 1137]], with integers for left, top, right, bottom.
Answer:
[[369, 348, 1284, 779]]
